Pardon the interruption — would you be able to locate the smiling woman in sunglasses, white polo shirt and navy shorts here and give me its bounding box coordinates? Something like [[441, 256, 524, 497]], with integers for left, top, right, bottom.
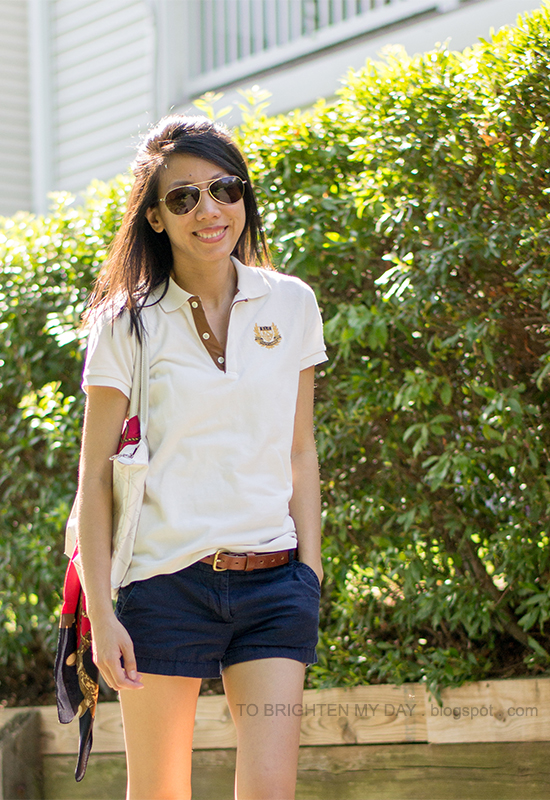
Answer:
[[79, 116, 326, 800]]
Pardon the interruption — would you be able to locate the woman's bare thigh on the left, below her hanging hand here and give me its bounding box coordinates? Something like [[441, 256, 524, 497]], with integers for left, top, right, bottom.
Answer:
[[120, 674, 201, 800]]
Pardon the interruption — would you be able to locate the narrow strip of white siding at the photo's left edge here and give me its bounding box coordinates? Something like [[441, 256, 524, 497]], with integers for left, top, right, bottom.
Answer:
[[0, 0, 31, 216]]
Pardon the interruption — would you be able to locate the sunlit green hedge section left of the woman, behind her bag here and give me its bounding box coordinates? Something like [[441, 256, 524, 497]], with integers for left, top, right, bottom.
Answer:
[[0, 178, 130, 702]]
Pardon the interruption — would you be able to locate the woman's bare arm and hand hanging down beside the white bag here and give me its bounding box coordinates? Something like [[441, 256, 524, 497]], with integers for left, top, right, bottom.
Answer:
[[78, 386, 146, 690]]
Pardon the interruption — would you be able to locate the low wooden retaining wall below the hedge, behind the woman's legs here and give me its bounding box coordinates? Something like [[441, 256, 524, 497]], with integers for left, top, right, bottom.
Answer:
[[0, 678, 550, 800]]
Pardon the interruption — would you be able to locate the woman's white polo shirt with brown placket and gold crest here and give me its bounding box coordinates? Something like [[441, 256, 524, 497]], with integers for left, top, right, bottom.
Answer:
[[82, 259, 327, 585]]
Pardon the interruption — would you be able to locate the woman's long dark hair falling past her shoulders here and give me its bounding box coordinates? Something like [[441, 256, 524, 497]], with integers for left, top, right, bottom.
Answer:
[[85, 115, 271, 337]]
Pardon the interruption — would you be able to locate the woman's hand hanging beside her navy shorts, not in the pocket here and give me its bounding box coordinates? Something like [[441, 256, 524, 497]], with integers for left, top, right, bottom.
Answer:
[[92, 614, 143, 691]]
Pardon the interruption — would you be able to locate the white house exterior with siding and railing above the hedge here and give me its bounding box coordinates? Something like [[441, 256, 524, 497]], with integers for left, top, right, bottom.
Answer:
[[0, 0, 540, 214]]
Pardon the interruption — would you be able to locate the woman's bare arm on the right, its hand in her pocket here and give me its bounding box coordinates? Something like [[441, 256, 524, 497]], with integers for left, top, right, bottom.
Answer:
[[290, 367, 323, 581]]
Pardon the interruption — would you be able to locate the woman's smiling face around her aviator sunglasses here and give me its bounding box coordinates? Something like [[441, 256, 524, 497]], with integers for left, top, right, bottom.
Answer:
[[146, 153, 246, 273]]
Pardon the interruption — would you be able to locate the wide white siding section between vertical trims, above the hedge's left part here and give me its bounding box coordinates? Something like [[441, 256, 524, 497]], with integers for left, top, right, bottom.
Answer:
[[51, 0, 155, 192]]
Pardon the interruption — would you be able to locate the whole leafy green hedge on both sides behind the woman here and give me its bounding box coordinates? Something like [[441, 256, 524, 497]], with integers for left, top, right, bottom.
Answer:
[[0, 4, 550, 708]]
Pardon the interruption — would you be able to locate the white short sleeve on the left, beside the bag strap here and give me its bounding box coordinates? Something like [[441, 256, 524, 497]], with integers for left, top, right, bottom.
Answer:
[[82, 313, 136, 397]]
